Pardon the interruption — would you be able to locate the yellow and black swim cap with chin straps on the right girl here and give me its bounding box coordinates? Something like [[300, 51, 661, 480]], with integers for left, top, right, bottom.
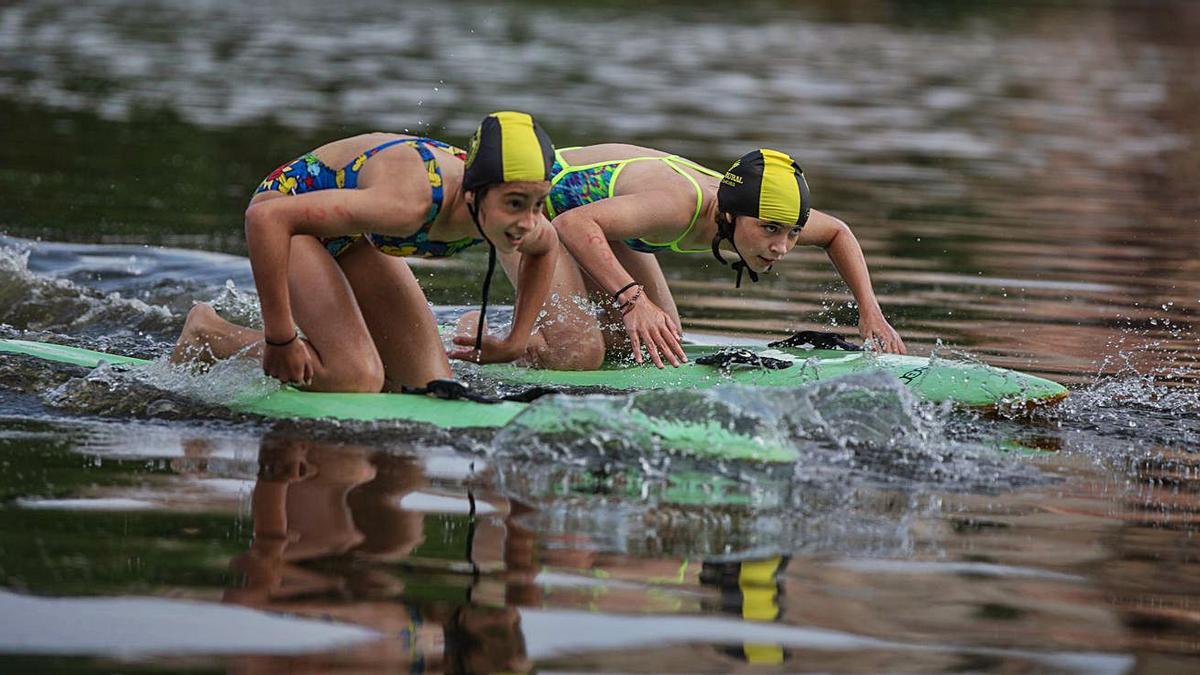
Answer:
[[713, 148, 811, 287]]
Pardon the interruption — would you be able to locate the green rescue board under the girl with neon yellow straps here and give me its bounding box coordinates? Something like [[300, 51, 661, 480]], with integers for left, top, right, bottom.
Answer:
[[480, 345, 1067, 406]]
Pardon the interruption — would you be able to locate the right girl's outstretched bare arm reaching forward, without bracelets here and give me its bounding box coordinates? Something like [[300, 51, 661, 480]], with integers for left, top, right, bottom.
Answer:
[[797, 211, 907, 354]]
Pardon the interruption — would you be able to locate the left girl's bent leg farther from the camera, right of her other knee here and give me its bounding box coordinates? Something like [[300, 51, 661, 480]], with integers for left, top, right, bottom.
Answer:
[[338, 240, 451, 392]]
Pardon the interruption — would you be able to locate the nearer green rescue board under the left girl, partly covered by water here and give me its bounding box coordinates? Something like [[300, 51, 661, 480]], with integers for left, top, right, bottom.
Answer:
[[0, 339, 797, 462]]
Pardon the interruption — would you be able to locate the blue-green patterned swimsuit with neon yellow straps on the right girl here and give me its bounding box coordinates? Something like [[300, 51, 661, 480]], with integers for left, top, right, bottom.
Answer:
[[546, 148, 721, 253]]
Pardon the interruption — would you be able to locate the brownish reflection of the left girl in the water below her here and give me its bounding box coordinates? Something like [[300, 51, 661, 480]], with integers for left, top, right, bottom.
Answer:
[[224, 437, 529, 673]]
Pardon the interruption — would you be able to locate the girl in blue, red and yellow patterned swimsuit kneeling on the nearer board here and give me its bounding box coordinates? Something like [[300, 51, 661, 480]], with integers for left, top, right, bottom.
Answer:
[[173, 112, 558, 392]]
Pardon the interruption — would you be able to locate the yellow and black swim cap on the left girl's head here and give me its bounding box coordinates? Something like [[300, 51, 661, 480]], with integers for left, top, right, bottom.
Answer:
[[462, 110, 554, 190]]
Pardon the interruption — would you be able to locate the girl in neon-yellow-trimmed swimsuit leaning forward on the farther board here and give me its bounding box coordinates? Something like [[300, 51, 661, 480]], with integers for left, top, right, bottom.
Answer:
[[487, 144, 905, 369]]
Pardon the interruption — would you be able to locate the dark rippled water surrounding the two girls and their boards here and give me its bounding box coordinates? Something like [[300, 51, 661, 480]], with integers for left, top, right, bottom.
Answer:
[[0, 0, 1200, 673]]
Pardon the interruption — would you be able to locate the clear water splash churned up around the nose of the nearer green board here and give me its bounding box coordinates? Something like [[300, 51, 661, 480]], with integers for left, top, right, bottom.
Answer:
[[493, 371, 1040, 488]]
